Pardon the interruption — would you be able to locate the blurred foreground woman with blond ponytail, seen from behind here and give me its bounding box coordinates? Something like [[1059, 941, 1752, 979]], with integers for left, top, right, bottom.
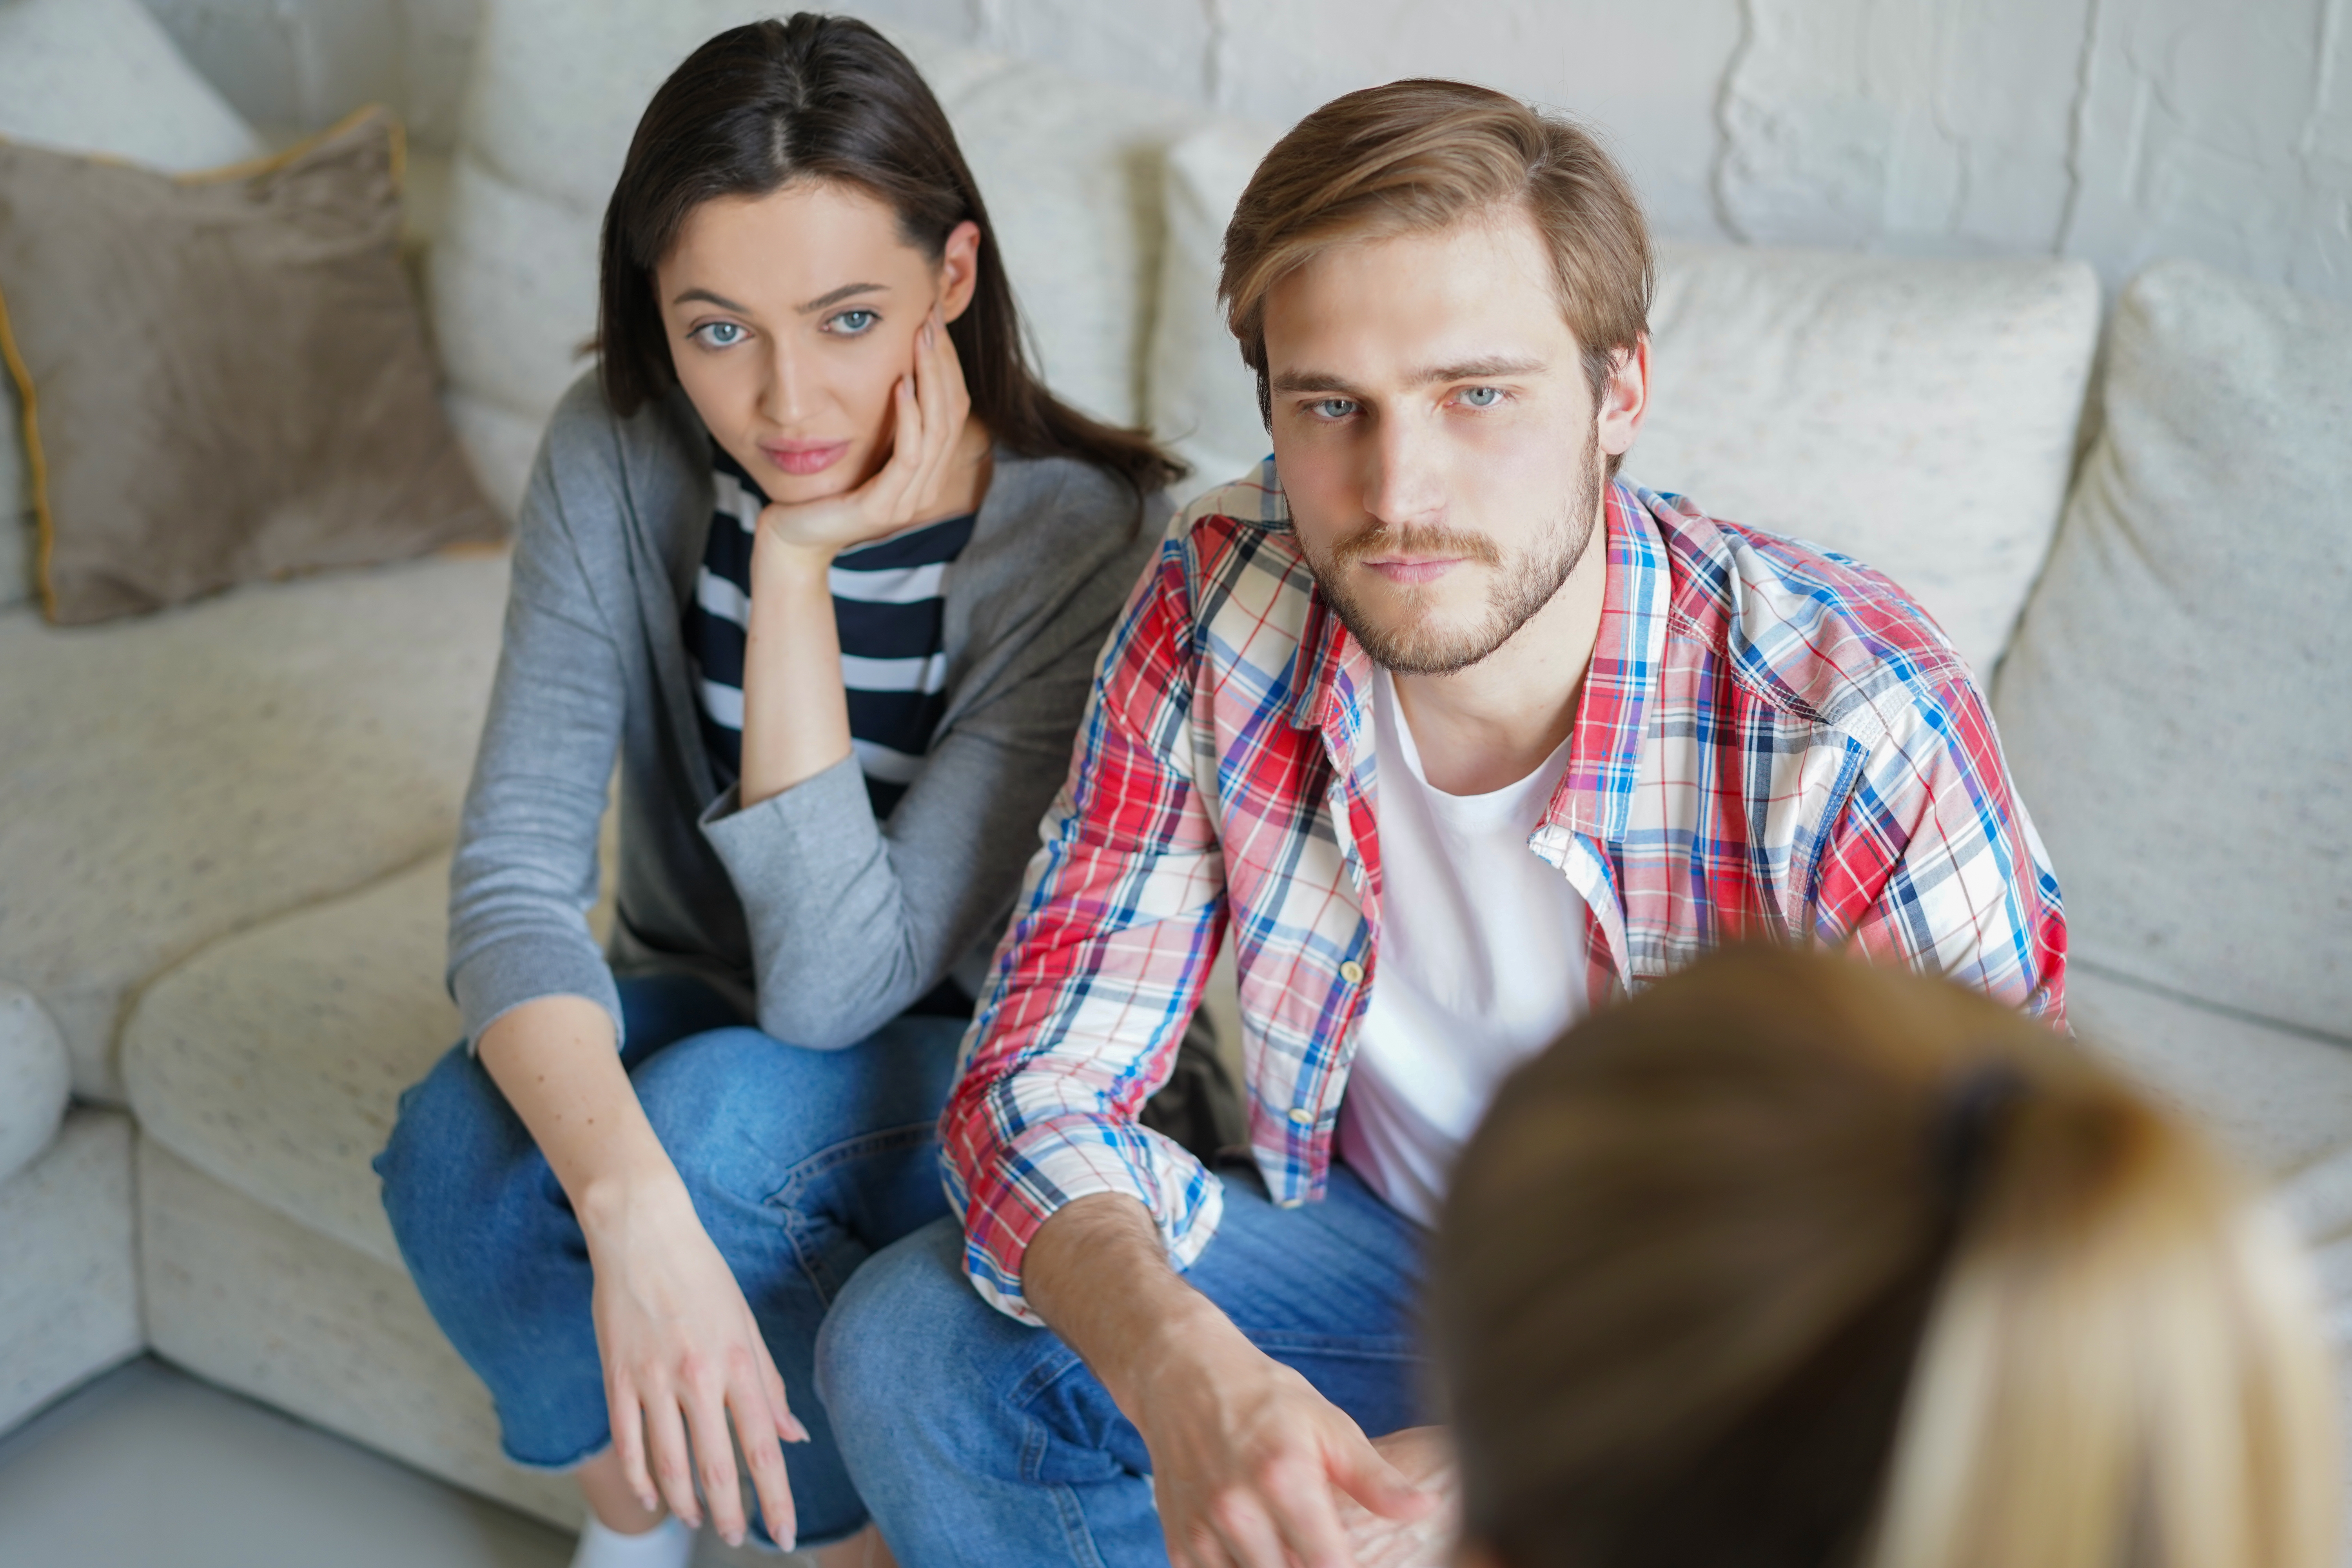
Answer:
[[1435, 950, 2338, 1568]]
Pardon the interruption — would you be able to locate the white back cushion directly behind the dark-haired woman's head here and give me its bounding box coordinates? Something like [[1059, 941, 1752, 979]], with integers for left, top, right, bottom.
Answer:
[[433, 0, 1200, 503]]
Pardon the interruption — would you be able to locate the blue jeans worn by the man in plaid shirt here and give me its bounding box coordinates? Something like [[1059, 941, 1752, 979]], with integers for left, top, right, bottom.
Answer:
[[816, 1166, 1428, 1568]]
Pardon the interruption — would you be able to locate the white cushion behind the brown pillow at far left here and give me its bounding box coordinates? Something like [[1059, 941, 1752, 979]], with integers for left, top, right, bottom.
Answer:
[[0, 0, 263, 604]]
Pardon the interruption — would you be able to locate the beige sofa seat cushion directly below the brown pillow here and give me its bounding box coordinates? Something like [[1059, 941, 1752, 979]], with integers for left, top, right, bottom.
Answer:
[[0, 552, 506, 1098]]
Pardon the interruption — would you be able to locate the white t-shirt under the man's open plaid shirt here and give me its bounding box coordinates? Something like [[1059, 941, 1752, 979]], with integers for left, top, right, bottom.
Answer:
[[1338, 670, 1585, 1225]]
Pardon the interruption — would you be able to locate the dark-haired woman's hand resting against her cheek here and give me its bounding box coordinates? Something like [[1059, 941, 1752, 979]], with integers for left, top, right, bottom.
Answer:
[[760, 306, 971, 562]]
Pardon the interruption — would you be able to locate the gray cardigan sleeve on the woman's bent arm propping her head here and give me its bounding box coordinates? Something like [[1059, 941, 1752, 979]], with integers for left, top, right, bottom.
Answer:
[[703, 479, 1155, 1051]]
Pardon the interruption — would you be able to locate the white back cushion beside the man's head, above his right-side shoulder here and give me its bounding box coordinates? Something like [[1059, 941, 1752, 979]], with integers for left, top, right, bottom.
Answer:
[[1625, 245, 2098, 682]]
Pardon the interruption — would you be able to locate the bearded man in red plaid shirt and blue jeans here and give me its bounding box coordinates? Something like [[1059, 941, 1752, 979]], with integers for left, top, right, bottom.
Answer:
[[818, 82, 2065, 1568]]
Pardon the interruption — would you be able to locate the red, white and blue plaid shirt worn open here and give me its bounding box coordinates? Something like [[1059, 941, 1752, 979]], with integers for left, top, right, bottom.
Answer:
[[941, 470, 2065, 1323]]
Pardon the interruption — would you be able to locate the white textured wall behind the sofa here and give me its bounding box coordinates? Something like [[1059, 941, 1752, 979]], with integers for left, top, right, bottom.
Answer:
[[148, 0, 2352, 301]]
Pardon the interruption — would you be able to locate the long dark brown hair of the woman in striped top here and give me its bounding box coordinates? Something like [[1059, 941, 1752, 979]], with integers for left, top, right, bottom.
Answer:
[[597, 12, 1183, 494]]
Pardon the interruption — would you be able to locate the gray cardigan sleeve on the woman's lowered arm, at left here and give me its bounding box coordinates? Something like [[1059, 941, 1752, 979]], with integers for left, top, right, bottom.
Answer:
[[449, 430, 628, 1044]]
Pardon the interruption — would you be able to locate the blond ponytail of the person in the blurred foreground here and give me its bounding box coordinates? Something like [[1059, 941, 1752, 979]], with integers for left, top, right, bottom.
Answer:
[[1870, 1060, 2338, 1568]]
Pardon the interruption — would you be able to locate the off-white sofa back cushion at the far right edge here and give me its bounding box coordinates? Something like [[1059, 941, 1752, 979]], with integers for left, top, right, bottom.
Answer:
[[1994, 261, 2352, 1044]]
